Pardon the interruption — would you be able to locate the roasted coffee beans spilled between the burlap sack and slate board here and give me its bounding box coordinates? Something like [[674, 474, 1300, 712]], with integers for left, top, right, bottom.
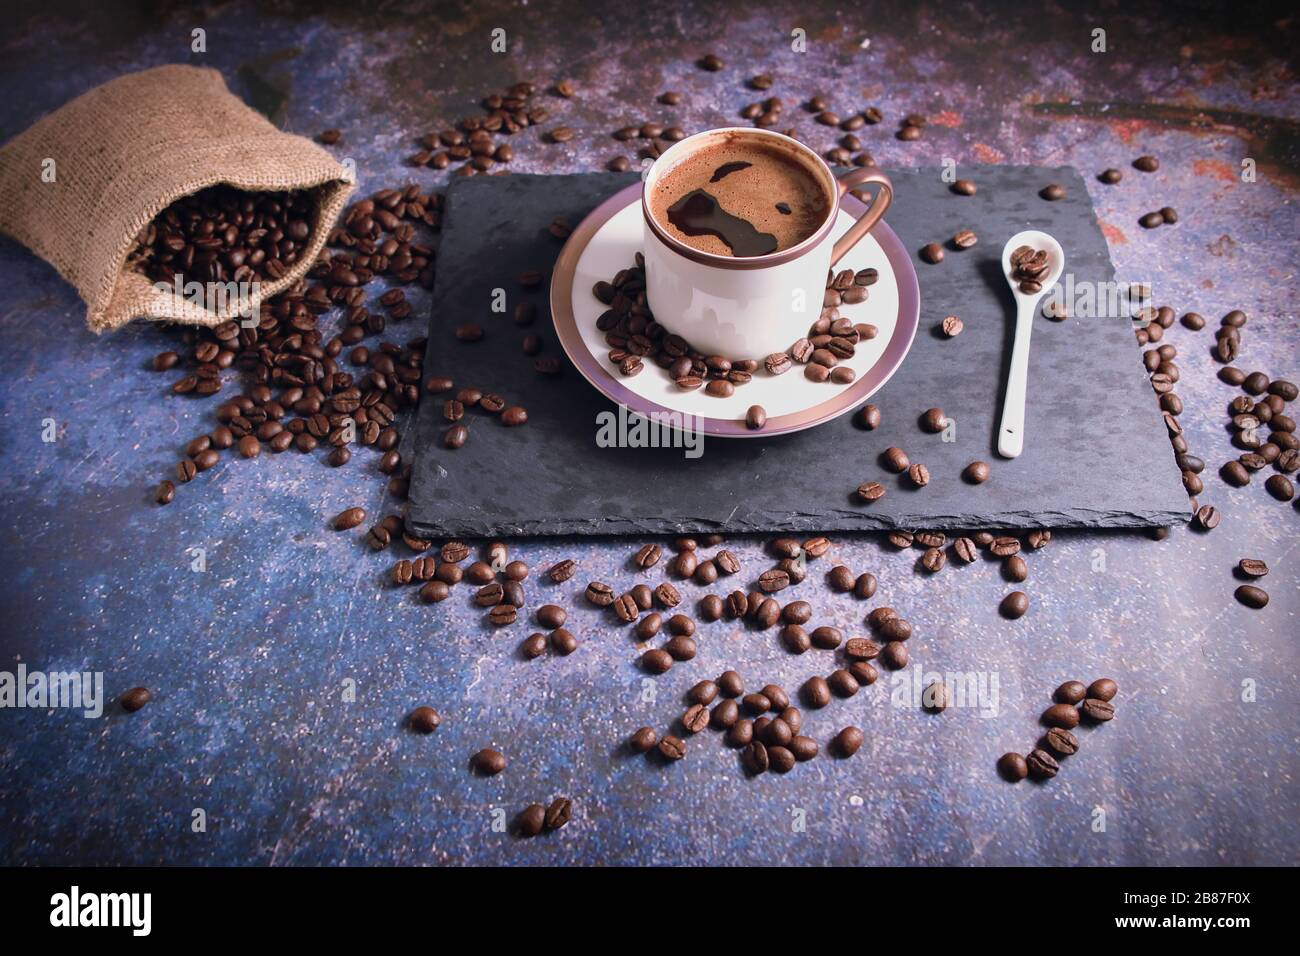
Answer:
[[152, 185, 442, 504]]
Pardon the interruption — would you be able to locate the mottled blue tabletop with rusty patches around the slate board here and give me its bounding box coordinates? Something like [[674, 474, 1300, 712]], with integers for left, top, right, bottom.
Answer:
[[0, 3, 1300, 865]]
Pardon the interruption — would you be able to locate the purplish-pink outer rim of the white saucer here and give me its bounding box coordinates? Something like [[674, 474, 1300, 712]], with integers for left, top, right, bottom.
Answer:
[[551, 182, 920, 438]]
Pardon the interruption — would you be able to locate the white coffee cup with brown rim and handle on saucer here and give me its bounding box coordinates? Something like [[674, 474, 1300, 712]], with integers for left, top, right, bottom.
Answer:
[[641, 126, 893, 359]]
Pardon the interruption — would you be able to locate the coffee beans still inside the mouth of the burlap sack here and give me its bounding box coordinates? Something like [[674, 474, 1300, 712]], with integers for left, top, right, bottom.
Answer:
[[126, 185, 317, 285]]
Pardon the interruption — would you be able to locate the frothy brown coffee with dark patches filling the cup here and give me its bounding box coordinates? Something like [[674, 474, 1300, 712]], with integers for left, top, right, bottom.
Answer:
[[647, 135, 835, 258]]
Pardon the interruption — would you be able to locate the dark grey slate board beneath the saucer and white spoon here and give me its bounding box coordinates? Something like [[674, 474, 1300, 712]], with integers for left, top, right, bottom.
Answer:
[[407, 166, 1188, 537]]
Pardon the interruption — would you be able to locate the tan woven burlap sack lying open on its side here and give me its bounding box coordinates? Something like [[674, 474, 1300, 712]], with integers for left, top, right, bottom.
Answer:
[[0, 66, 352, 332]]
